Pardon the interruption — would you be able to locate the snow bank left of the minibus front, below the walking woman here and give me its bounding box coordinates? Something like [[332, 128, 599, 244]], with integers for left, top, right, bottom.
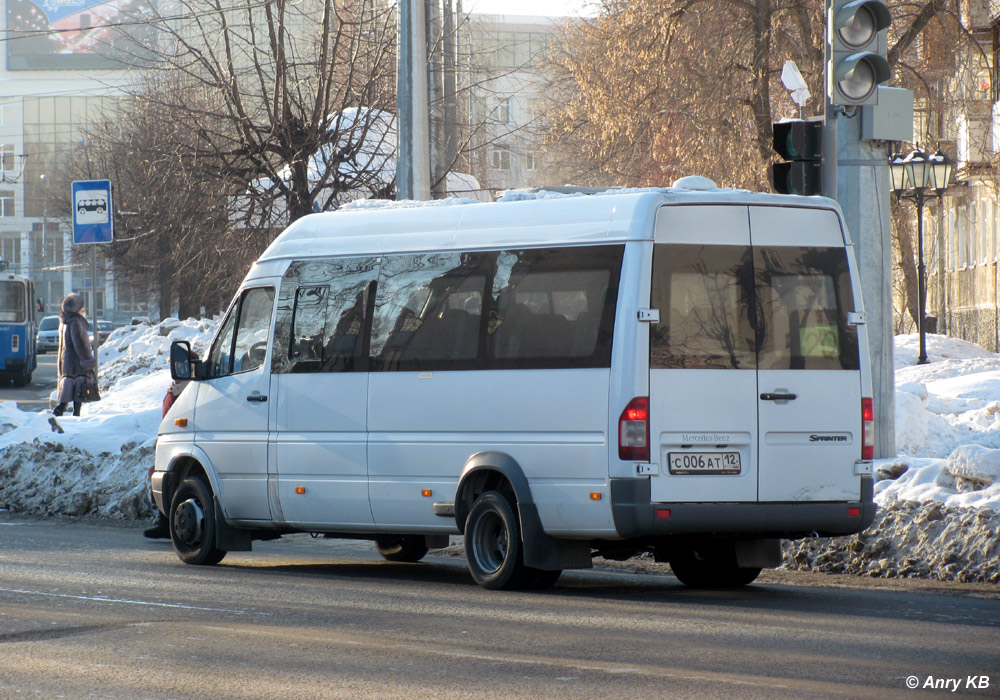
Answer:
[[0, 318, 216, 518]]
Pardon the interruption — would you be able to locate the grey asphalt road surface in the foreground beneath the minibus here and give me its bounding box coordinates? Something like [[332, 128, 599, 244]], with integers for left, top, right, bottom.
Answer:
[[0, 512, 1000, 700]]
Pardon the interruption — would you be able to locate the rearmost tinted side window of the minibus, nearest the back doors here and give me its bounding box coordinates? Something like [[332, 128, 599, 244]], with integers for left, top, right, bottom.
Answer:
[[488, 246, 624, 369]]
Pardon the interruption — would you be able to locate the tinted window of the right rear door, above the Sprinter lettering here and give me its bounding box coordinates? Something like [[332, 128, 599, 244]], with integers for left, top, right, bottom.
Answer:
[[754, 247, 859, 369]]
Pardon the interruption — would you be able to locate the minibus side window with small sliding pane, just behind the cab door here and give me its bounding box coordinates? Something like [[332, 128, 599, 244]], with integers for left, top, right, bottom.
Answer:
[[271, 258, 379, 374]]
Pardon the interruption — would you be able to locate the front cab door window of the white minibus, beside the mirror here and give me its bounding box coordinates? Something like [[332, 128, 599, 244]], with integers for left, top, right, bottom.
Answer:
[[208, 287, 274, 377]]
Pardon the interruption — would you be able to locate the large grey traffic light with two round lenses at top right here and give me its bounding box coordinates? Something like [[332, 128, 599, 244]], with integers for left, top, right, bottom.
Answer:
[[826, 0, 892, 107]]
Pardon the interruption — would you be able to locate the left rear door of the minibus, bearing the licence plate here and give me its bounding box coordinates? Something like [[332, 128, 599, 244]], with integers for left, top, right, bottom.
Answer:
[[649, 206, 757, 502]]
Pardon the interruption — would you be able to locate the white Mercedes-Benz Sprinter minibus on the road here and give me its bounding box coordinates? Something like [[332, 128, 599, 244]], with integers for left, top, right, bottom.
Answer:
[[153, 178, 875, 589]]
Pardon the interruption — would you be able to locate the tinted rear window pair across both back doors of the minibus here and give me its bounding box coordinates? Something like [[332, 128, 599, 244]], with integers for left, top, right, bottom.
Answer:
[[650, 244, 859, 369]]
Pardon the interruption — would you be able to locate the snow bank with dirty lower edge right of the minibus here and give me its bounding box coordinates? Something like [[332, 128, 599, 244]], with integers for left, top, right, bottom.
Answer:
[[784, 335, 1000, 583]]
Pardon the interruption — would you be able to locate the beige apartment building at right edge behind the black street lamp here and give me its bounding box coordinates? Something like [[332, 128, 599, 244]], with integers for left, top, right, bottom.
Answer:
[[924, 0, 1000, 352]]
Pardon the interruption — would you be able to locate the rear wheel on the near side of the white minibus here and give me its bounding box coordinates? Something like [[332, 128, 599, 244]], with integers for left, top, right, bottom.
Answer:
[[465, 491, 536, 590]]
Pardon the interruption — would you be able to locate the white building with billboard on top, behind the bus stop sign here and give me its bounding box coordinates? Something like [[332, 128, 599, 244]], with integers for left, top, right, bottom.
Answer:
[[0, 0, 148, 321]]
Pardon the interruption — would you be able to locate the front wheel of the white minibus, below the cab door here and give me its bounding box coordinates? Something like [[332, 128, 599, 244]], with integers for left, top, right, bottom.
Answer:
[[169, 476, 226, 566]]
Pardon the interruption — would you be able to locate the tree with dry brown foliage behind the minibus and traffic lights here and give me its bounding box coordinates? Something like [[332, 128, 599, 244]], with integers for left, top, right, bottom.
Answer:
[[550, 0, 960, 189]]
